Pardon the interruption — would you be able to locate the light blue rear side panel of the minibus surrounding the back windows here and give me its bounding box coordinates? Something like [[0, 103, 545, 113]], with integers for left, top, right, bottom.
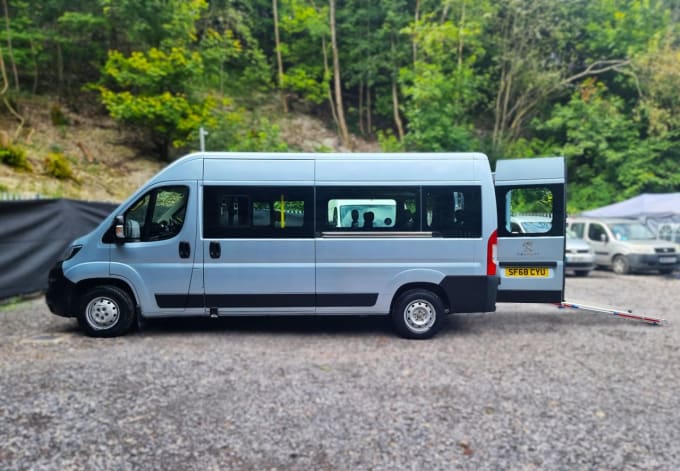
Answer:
[[316, 156, 498, 314]]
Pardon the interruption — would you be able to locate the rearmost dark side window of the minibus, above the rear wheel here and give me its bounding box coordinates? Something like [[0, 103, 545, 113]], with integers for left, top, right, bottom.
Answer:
[[423, 186, 482, 237]]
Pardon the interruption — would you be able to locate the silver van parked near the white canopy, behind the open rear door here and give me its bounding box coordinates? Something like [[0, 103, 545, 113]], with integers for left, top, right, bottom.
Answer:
[[567, 217, 680, 274]]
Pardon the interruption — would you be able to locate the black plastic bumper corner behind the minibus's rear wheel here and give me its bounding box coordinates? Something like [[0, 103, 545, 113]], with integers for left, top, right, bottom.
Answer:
[[439, 276, 499, 312]]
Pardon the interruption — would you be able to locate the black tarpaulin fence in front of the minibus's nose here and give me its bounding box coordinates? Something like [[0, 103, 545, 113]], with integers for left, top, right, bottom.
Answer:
[[0, 199, 117, 299]]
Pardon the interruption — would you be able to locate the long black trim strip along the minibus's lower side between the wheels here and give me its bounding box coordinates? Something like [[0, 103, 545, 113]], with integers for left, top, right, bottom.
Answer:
[[156, 293, 378, 309]]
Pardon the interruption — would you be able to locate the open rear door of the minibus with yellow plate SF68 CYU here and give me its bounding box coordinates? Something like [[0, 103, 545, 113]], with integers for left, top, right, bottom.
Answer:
[[495, 157, 566, 303]]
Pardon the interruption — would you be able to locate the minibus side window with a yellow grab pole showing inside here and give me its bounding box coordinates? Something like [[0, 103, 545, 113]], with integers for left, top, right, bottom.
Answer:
[[203, 186, 314, 239]]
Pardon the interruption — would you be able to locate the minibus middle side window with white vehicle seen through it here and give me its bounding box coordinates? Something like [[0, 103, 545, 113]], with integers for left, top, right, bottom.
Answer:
[[316, 186, 420, 232]]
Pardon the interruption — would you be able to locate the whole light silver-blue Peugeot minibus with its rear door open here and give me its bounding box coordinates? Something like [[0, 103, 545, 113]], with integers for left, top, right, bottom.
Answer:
[[46, 153, 564, 338]]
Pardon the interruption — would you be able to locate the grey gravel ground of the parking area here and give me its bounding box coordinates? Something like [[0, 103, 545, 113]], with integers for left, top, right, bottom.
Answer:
[[0, 272, 680, 470]]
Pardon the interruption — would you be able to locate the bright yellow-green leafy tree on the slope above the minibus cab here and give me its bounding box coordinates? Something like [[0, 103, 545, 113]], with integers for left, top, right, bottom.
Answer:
[[98, 0, 217, 160]]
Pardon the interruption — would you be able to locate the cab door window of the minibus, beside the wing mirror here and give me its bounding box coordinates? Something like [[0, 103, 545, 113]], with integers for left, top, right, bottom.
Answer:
[[125, 186, 189, 242]]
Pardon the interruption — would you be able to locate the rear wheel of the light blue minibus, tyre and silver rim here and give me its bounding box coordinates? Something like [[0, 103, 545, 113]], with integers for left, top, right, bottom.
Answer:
[[392, 289, 444, 339]]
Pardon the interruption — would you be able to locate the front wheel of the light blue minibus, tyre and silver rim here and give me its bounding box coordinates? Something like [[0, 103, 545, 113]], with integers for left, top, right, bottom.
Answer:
[[78, 285, 135, 337]]
